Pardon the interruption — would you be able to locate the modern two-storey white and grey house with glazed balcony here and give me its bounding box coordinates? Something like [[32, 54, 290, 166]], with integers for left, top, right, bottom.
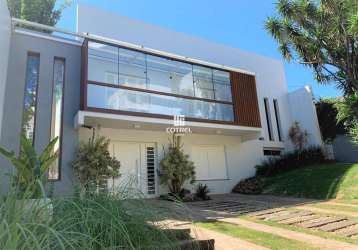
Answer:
[[0, 0, 322, 196]]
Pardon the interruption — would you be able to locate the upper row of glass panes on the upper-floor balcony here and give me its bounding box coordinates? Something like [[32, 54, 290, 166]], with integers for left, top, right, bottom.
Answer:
[[88, 41, 232, 102]]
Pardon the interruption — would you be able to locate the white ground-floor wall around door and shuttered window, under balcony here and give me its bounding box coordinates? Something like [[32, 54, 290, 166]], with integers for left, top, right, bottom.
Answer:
[[80, 128, 262, 193]]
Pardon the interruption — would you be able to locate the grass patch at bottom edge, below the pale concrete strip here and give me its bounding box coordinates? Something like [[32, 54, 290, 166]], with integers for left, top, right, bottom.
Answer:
[[197, 222, 318, 250]]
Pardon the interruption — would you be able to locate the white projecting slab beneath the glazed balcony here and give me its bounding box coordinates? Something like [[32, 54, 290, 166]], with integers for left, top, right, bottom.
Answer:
[[74, 111, 262, 140]]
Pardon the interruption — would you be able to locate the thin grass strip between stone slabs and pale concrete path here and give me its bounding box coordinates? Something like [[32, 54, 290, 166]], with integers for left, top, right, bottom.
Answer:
[[240, 216, 358, 245]]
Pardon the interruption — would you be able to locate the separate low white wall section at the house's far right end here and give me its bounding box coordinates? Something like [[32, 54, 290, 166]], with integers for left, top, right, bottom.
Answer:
[[288, 86, 322, 145]]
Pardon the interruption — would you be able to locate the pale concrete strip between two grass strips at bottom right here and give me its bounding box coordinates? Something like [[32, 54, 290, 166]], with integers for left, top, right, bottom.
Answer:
[[219, 218, 358, 250]]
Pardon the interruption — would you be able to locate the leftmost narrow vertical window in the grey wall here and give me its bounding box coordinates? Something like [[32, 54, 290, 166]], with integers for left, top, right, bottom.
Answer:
[[22, 53, 40, 144]]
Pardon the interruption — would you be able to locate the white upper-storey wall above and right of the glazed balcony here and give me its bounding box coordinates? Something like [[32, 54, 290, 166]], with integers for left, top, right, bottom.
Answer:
[[77, 4, 291, 147]]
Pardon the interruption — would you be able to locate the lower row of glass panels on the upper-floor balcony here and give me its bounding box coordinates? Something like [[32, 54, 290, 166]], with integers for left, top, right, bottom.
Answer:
[[87, 84, 234, 121]]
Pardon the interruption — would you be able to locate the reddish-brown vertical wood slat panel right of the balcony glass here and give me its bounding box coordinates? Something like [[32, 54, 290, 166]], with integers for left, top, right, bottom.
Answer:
[[231, 72, 261, 127]]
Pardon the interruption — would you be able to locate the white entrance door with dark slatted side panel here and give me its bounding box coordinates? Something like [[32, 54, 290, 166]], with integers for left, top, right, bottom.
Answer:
[[109, 142, 157, 196]]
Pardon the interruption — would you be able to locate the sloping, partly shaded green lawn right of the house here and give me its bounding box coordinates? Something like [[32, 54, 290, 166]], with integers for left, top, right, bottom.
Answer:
[[264, 163, 358, 200]]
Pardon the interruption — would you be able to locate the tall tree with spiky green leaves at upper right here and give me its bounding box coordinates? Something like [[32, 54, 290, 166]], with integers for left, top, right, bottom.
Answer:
[[265, 0, 358, 94]]
